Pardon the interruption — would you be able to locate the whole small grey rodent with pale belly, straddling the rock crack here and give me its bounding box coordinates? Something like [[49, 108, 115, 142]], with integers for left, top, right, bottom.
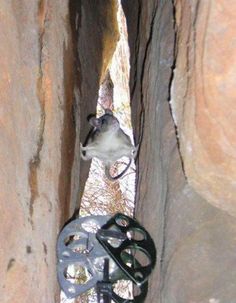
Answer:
[[80, 109, 138, 181]]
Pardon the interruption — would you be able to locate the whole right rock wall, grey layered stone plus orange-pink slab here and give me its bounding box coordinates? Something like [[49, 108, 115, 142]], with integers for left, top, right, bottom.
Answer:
[[122, 0, 236, 303]]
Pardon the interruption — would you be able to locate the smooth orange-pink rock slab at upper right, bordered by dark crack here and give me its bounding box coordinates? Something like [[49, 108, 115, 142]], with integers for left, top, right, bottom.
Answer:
[[171, 0, 236, 216]]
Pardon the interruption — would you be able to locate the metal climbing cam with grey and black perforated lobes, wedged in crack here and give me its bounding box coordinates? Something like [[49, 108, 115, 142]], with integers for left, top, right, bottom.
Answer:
[[57, 214, 156, 303]]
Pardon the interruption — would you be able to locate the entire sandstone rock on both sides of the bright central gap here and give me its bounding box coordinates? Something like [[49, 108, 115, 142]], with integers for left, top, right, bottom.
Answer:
[[0, 0, 236, 303]]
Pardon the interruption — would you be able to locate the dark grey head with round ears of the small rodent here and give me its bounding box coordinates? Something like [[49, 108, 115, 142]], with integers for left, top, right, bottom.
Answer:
[[89, 109, 120, 132]]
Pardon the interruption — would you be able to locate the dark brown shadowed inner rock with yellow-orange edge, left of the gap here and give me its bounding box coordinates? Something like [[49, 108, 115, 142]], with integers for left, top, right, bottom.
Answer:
[[70, 0, 119, 208]]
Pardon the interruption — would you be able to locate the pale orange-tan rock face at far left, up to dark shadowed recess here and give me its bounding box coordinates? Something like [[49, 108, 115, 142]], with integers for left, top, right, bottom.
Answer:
[[0, 0, 74, 303]]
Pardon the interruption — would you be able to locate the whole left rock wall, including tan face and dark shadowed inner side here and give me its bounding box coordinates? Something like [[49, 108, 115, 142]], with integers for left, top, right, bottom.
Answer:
[[0, 0, 119, 303]]
